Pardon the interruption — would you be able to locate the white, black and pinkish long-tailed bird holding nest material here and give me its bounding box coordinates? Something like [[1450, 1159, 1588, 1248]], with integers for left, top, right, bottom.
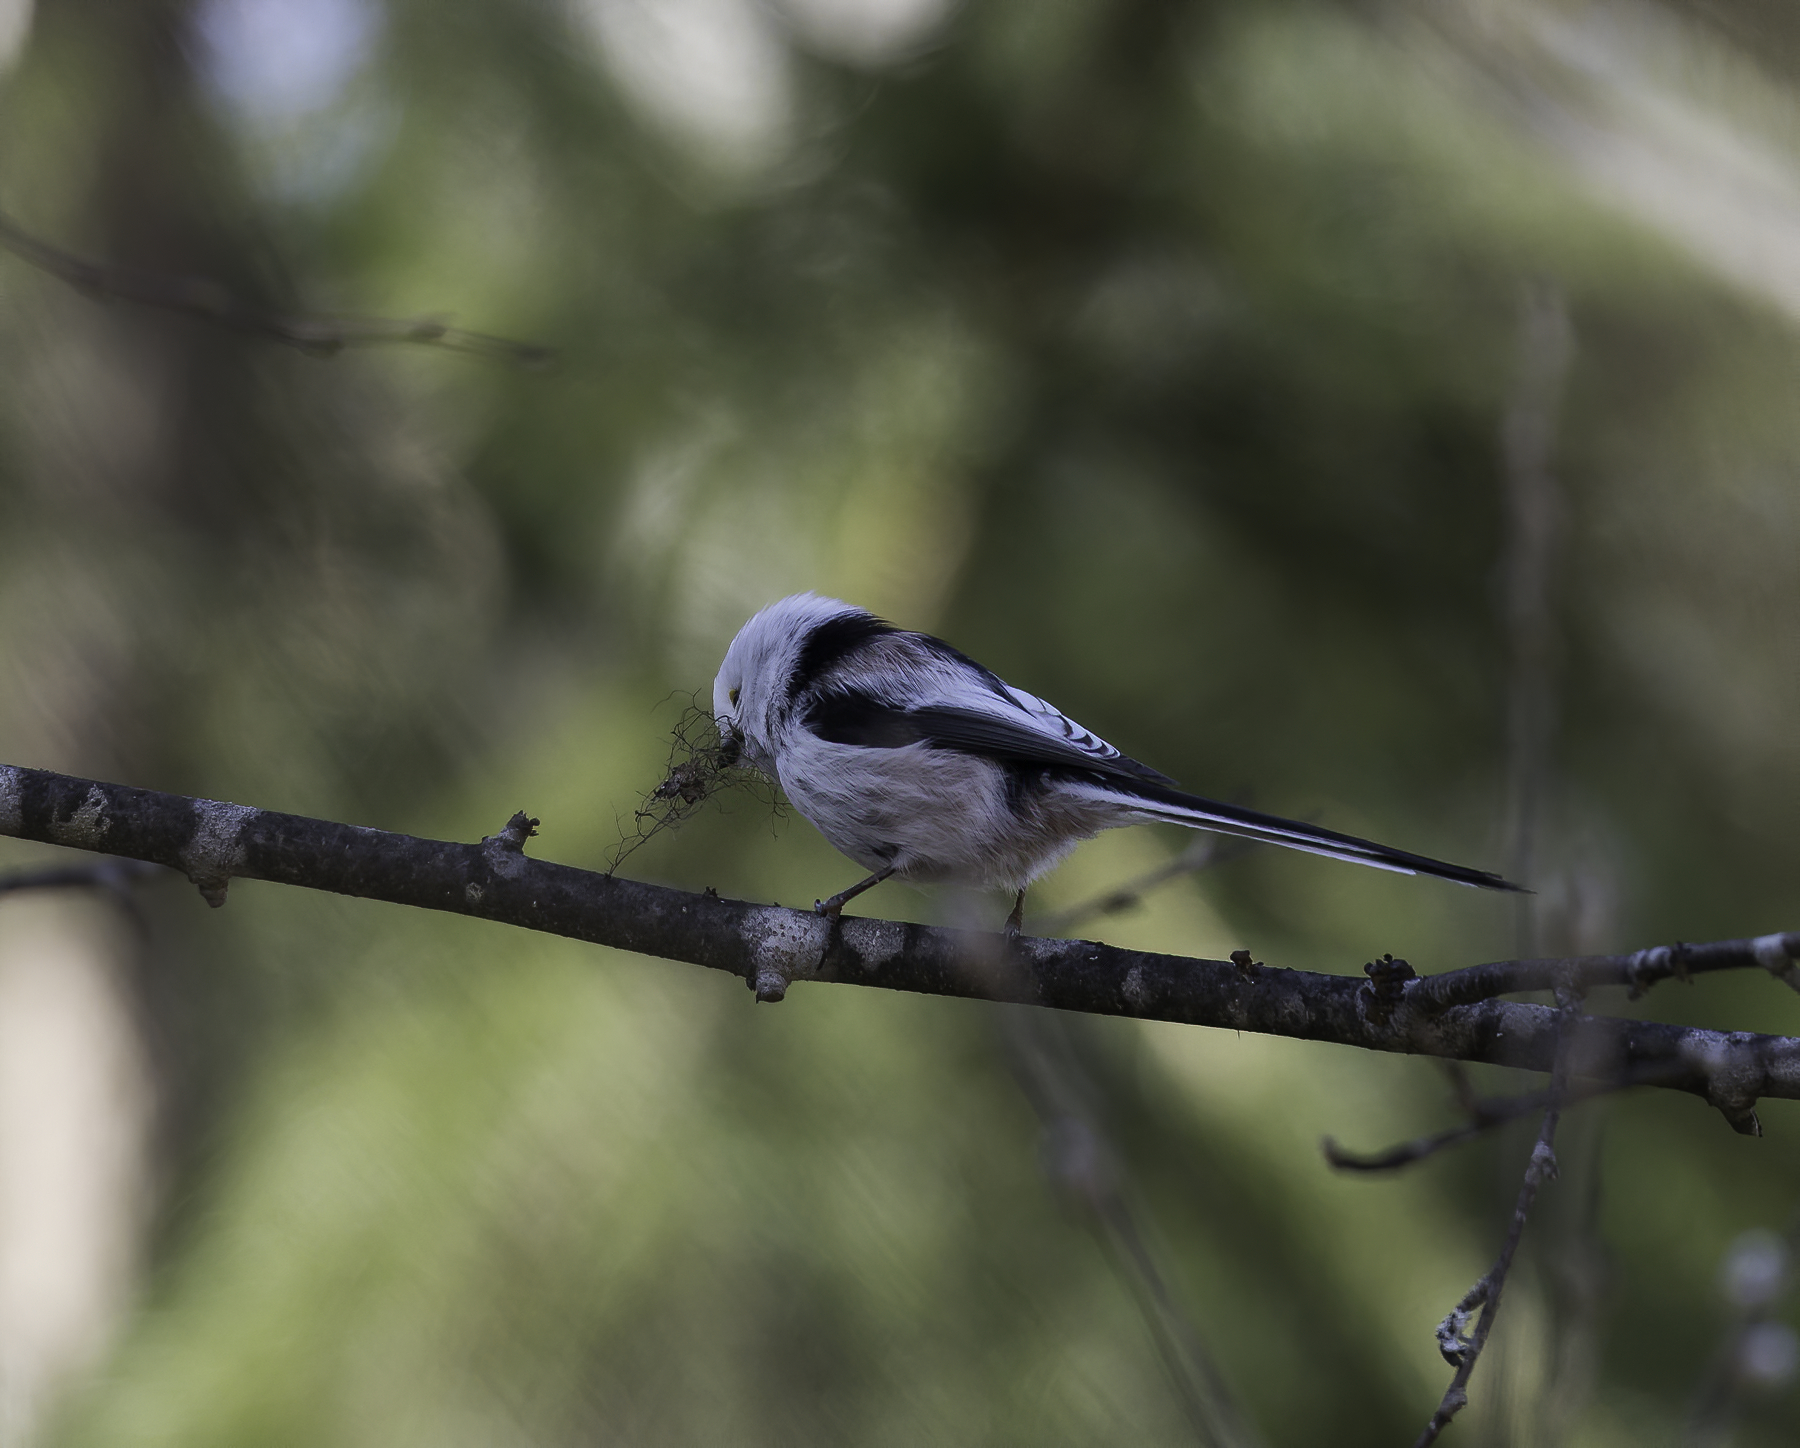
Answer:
[[713, 593, 1523, 935]]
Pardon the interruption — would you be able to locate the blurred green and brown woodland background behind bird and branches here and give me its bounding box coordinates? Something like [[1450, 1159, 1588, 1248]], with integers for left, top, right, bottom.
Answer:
[[0, 0, 1800, 1448]]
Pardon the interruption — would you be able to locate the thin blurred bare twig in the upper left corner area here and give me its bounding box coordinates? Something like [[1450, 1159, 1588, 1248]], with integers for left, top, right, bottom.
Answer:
[[0, 214, 556, 367]]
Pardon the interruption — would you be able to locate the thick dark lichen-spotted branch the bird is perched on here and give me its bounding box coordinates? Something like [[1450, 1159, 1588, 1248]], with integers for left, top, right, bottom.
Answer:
[[0, 765, 1800, 1131]]
